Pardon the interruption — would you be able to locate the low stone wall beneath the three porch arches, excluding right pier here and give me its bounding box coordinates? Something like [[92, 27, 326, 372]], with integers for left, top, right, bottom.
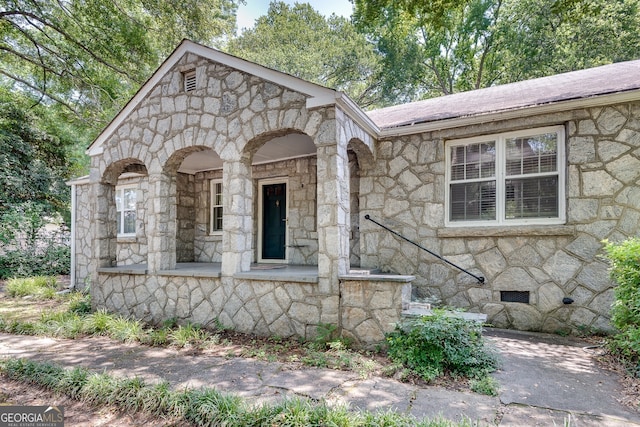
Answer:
[[91, 273, 338, 338]]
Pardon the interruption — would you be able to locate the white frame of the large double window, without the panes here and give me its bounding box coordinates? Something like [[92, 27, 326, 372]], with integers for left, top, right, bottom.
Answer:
[[444, 126, 566, 227]]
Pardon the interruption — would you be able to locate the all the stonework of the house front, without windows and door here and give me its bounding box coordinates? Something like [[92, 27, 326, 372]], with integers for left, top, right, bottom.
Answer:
[[73, 43, 640, 345]]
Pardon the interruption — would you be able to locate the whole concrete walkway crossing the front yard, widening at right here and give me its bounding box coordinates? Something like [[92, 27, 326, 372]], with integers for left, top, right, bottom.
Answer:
[[0, 330, 640, 427]]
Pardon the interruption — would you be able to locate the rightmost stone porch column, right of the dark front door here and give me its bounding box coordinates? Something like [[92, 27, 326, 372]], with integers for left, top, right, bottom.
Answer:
[[315, 120, 350, 298]]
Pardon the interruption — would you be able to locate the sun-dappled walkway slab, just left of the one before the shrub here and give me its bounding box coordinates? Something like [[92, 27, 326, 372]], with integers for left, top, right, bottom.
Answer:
[[330, 378, 417, 413]]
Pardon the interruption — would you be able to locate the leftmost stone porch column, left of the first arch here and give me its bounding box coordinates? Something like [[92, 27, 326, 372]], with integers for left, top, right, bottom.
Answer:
[[91, 182, 117, 267]]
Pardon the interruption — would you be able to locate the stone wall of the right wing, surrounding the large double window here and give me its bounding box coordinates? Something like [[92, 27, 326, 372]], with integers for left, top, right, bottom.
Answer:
[[360, 104, 640, 332]]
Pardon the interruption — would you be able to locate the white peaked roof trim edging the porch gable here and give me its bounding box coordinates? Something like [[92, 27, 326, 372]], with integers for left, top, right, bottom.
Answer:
[[87, 39, 379, 156]]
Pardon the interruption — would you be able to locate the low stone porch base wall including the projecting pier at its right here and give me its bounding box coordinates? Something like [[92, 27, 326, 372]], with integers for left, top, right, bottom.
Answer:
[[93, 273, 411, 346]]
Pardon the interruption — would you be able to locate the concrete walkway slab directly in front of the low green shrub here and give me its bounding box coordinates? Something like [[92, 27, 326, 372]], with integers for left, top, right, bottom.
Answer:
[[410, 387, 500, 425]]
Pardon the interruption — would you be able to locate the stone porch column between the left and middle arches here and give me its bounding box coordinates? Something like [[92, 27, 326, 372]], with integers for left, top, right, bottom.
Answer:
[[147, 172, 176, 274]]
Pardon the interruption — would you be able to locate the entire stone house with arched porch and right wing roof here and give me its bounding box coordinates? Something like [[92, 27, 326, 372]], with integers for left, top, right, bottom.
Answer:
[[70, 41, 640, 345]]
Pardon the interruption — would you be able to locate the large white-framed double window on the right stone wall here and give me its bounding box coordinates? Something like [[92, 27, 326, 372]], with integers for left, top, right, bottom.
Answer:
[[446, 127, 565, 226]]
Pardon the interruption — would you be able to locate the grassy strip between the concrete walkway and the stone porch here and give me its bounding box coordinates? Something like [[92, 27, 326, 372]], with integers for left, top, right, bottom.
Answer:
[[0, 281, 493, 394]]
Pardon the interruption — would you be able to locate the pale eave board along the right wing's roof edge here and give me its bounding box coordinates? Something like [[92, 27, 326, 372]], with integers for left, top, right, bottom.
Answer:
[[378, 88, 640, 138]]
